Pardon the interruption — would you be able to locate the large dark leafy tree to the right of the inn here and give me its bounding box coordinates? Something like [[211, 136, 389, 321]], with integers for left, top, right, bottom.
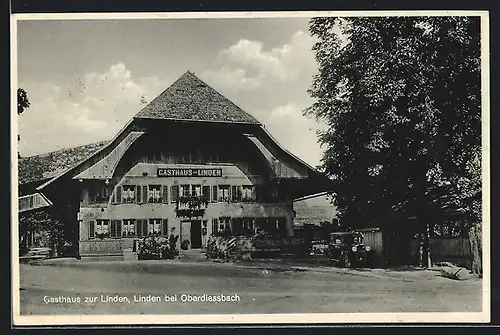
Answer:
[[305, 17, 481, 263]]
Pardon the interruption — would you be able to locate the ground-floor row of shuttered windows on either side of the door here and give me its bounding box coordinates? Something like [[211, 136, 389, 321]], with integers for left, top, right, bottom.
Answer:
[[89, 217, 286, 239]]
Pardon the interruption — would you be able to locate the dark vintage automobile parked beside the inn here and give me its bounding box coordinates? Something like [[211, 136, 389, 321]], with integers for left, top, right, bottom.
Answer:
[[326, 232, 373, 268]]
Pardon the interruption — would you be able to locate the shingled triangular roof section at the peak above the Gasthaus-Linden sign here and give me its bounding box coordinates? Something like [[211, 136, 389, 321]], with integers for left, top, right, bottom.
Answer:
[[135, 71, 260, 124]]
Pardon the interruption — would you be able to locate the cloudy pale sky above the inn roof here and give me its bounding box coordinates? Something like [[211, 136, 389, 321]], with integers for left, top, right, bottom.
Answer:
[[17, 18, 324, 166]]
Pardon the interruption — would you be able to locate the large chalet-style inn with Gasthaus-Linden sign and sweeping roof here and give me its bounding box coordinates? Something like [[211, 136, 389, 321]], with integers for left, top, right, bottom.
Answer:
[[19, 71, 329, 257]]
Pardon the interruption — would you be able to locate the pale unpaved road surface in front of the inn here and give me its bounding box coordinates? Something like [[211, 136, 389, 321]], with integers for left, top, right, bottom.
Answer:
[[20, 261, 482, 315]]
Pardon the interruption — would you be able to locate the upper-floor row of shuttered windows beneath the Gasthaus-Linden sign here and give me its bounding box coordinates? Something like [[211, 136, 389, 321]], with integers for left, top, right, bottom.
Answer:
[[90, 185, 278, 204]]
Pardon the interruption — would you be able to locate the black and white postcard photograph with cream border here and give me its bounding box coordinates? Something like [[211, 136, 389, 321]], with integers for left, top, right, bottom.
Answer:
[[11, 11, 490, 325]]
